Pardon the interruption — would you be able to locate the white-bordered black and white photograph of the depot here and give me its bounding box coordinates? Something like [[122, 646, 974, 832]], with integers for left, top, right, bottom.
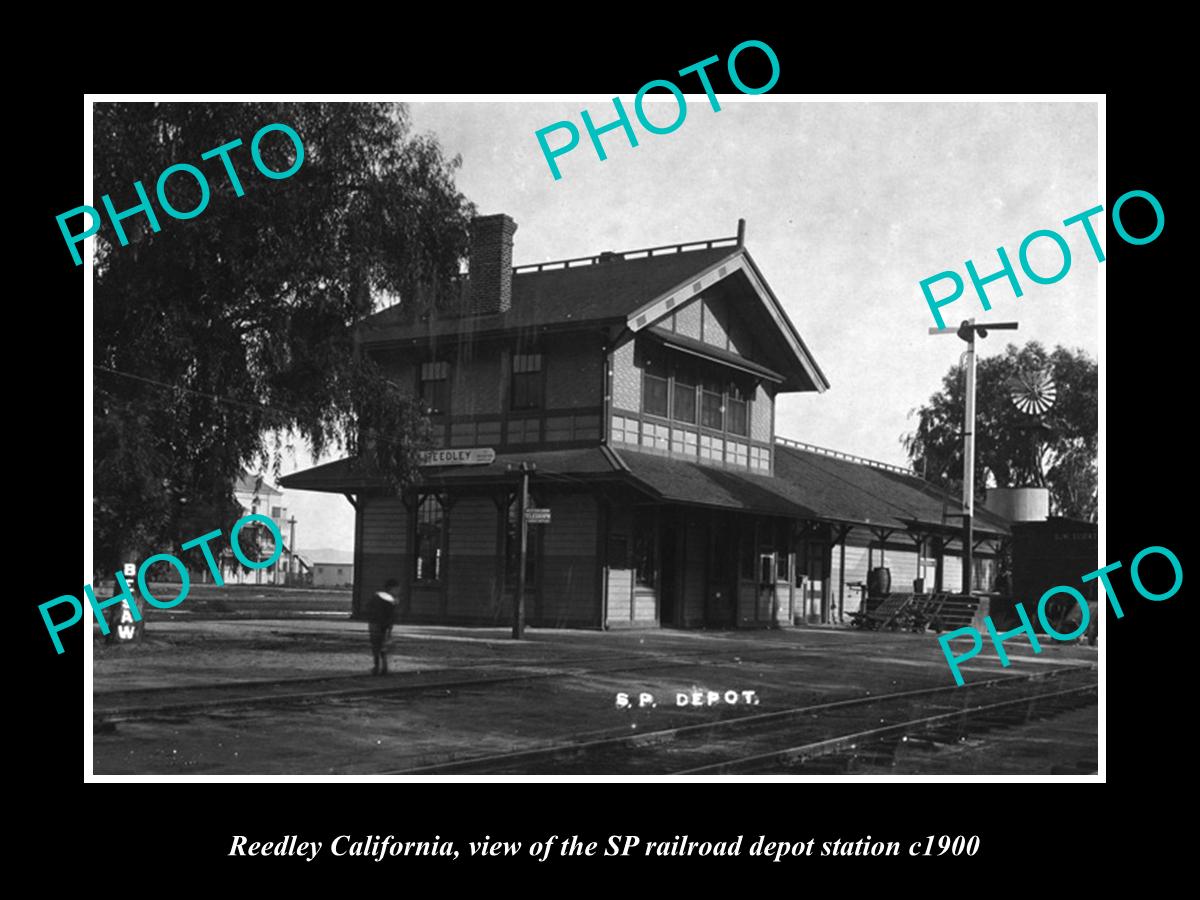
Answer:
[[79, 95, 1099, 782]]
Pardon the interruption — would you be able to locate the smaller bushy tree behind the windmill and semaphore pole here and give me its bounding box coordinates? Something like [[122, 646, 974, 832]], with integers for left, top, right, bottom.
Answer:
[[901, 341, 1098, 521]]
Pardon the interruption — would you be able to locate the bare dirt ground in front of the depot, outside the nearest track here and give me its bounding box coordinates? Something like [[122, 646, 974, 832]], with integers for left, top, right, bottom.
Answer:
[[94, 602, 1096, 774]]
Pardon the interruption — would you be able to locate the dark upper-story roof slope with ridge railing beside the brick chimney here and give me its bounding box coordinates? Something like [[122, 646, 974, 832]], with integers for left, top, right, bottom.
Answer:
[[360, 246, 740, 343]]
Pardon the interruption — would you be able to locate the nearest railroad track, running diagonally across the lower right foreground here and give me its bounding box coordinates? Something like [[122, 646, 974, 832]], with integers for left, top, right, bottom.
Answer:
[[380, 666, 1097, 775]]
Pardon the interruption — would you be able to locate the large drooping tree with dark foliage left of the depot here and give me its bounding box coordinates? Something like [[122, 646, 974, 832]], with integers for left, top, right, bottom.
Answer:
[[92, 103, 474, 572]]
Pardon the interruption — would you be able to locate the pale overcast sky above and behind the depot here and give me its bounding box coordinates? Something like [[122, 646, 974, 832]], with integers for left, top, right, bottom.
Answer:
[[284, 95, 1106, 550]]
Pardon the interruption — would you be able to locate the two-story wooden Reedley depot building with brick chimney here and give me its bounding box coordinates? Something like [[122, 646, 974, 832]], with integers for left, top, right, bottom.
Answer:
[[282, 215, 1007, 628]]
